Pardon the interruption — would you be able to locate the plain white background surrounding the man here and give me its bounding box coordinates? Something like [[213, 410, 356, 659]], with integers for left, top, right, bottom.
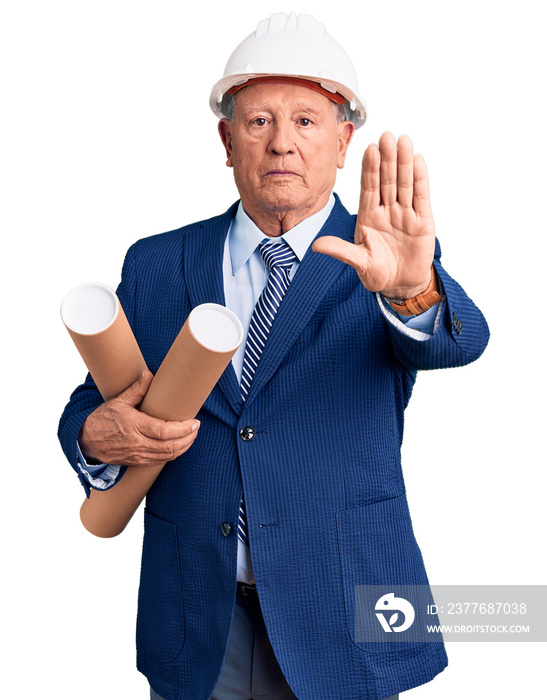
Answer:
[[0, 0, 547, 700]]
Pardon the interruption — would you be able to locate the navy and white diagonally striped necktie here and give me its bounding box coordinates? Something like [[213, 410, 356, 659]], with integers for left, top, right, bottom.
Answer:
[[237, 239, 296, 546]]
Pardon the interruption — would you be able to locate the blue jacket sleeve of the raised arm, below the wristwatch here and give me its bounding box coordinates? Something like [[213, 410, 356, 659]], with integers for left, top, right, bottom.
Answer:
[[388, 241, 490, 370]]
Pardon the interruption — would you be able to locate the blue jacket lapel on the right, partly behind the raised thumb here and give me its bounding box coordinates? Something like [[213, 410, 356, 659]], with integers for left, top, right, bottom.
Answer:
[[246, 197, 355, 405]]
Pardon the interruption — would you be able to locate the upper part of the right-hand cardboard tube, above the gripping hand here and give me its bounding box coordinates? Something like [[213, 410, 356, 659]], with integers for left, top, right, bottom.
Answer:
[[140, 304, 243, 421]]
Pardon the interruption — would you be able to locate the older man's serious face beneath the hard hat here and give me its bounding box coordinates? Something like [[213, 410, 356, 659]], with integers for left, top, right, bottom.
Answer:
[[219, 83, 354, 228]]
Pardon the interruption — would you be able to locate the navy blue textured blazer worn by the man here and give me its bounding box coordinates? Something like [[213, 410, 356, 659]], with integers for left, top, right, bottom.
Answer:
[[59, 198, 488, 700]]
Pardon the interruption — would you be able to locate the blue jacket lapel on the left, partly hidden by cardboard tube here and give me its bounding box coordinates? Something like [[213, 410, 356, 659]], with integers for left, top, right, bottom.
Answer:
[[184, 202, 243, 415]]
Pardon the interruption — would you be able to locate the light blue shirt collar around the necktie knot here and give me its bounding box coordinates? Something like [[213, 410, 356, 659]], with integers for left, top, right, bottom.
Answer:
[[228, 193, 335, 275]]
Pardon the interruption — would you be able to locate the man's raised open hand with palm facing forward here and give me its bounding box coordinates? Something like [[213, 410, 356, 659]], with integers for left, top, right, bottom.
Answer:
[[313, 132, 435, 299]]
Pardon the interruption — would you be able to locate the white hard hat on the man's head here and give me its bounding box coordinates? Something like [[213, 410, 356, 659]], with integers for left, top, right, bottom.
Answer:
[[209, 12, 366, 129]]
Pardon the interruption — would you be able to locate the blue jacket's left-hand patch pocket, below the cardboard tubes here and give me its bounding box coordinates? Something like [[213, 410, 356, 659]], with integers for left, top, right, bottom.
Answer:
[[137, 511, 184, 663]]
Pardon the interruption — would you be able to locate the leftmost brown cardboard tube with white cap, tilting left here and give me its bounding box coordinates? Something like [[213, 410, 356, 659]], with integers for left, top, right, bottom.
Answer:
[[61, 282, 146, 401]]
